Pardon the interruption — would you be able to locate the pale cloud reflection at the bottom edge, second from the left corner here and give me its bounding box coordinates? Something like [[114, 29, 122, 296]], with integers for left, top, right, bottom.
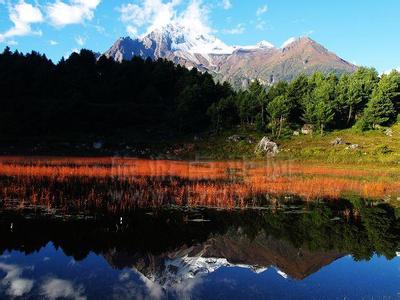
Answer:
[[40, 278, 86, 299]]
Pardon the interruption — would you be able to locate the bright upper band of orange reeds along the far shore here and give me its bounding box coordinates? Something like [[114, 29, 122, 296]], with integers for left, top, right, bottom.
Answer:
[[0, 157, 400, 179]]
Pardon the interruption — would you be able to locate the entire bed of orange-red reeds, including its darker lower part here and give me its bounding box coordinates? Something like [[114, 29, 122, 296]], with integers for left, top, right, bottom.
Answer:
[[0, 158, 400, 211]]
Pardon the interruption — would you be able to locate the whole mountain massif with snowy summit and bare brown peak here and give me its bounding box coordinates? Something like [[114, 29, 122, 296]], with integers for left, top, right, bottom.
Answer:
[[104, 24, 357, 87]]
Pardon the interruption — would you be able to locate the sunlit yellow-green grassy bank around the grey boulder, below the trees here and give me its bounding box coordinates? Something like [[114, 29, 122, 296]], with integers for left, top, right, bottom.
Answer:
[[191, 123, 400, 168]]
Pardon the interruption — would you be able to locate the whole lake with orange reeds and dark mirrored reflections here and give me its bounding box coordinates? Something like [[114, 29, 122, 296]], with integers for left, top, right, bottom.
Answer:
[[0, 157, 400, 299]]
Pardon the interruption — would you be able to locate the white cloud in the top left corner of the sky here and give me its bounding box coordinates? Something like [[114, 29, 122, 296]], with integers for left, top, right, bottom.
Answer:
[[0, 0, 43, 42]]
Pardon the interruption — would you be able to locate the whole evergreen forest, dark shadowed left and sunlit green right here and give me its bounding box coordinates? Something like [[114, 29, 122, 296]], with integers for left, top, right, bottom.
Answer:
[[0, 48, 400, 138]]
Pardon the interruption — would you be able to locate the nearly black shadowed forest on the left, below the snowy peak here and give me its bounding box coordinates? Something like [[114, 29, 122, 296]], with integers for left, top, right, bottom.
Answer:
[[0, 48, 232, 136]]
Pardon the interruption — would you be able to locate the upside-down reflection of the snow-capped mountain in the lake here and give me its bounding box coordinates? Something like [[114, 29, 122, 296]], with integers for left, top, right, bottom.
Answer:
[[103, 230, 344, 290]]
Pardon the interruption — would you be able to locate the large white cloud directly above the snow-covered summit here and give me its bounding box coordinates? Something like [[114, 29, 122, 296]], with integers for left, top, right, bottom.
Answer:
[[119, 0, 212, 35]]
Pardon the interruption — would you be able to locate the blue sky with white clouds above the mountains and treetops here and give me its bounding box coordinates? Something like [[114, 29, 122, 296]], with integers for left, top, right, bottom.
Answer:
[[0, 0, 400, 72]]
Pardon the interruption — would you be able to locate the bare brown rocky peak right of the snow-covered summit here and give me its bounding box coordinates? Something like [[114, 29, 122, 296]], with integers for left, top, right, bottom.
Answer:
[[211, 37, 356, 86]]
